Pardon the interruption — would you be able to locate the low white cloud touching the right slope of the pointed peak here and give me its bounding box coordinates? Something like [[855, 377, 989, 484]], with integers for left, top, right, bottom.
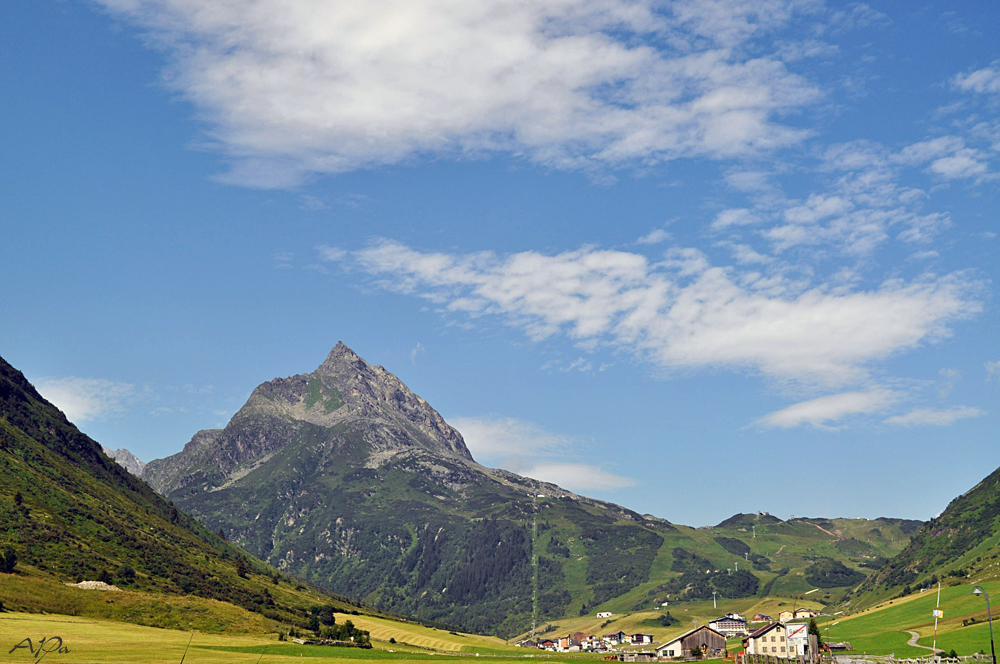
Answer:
[[449, 417, 635, 491]]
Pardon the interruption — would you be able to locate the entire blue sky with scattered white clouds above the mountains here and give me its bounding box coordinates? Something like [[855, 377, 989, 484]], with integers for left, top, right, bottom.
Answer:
[[0, 0, 1000, 525]]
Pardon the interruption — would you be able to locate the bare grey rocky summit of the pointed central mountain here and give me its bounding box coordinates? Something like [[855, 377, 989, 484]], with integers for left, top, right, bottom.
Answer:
[[142, 341, 473, 493]]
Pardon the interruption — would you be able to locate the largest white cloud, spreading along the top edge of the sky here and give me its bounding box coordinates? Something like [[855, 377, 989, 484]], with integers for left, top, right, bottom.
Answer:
[[94, 0, 821, 187]]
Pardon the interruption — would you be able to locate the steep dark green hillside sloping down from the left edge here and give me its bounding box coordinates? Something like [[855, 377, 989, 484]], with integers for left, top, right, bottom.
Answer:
[[0, 358, 353, 625]]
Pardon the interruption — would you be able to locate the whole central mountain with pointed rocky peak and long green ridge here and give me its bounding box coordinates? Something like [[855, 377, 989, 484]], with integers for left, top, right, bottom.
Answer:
[[143, 342, 920, 635]]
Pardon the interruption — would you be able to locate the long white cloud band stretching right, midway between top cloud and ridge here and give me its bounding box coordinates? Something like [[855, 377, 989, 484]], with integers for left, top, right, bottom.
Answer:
[[338, 240, 981, 384]]
